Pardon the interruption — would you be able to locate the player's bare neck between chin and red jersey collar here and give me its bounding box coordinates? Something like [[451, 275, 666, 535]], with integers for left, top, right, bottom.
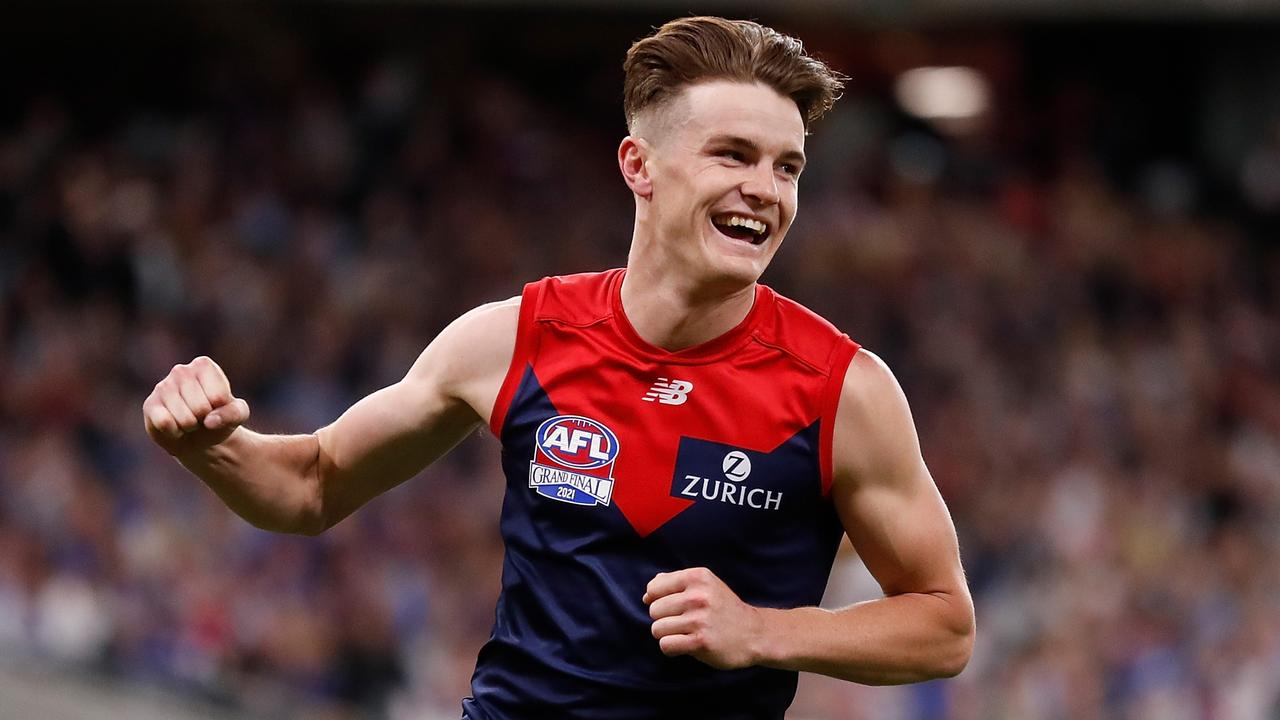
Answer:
[[622, 263, 755, 351]]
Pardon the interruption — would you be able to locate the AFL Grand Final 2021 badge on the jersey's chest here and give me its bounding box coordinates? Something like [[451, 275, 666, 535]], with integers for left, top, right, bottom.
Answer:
[[529, 415, 618, 505]]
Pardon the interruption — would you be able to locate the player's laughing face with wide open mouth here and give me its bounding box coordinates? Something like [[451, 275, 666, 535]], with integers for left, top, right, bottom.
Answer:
[[623, 81, 804, 286]]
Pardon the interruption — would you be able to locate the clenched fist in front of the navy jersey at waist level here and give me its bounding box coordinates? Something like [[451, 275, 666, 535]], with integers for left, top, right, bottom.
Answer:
[[644, 568, 763, 670]]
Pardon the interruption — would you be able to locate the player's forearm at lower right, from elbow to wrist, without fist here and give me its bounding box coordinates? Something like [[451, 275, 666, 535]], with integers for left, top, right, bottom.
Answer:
[[759, 593, 974, 685]]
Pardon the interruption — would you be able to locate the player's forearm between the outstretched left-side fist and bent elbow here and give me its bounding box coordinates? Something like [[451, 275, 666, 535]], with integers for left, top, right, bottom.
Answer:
[[178, 427, 325, 534]]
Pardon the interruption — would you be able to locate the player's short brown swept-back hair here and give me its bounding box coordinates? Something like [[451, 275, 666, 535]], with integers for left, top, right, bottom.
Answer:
[[622, 17, 845, 131]]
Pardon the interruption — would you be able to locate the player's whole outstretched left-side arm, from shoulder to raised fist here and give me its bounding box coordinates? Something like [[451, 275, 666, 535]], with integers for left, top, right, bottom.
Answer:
[[142, 299, 520, 534]]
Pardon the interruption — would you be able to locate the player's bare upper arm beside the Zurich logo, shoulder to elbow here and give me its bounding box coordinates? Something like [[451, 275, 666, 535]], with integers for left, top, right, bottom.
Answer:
[[832, 350, 966, 594]]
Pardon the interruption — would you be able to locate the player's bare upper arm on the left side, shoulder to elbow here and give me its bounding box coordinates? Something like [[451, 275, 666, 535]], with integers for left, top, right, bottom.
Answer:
[[316, 299, 520, 524]]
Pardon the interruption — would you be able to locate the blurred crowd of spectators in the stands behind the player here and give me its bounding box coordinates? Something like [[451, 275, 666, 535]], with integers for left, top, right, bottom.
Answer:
[[0, 9, 1280, 720]]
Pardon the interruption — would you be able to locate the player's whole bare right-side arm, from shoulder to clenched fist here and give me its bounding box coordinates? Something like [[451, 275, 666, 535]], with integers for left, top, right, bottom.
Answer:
[[644, 351, 974, 684]]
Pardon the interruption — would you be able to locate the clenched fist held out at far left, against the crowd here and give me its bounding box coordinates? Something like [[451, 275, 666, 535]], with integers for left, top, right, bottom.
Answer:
[[142, 356, 248, 456]]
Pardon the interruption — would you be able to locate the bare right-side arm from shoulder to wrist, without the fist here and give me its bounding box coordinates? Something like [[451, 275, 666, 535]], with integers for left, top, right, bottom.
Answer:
[[760, 351, 974, 684]]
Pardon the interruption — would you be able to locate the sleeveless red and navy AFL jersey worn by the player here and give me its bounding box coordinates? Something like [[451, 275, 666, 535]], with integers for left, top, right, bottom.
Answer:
[[463, 270, 858, 720]]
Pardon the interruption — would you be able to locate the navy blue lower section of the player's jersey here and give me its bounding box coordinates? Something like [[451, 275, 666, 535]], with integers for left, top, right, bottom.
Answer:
[[465, 368, 840, 720]]
